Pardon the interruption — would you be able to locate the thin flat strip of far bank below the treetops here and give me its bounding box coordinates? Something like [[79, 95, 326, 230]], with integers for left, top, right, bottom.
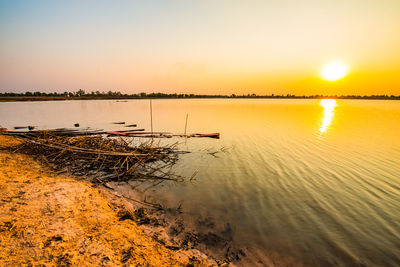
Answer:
[[0, 95, 400, 102]]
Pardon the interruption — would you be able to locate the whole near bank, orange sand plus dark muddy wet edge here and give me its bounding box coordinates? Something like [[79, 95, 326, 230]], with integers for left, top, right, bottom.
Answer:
[[0, 134, 303, 267]]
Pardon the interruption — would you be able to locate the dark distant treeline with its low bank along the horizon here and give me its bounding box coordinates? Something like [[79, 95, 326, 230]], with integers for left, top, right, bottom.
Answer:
[[0, 89, 400, 101]]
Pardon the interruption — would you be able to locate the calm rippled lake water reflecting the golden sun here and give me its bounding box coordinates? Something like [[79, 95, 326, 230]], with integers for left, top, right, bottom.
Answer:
[[0, 99, 400, 266]]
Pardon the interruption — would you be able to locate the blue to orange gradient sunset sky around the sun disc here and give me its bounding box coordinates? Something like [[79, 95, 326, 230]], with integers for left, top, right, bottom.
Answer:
[[0, 0, 400, 95]]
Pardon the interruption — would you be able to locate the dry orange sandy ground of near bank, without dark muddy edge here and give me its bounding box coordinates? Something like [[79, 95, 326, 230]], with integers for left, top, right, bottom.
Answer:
[[0, 135, 210, 266]]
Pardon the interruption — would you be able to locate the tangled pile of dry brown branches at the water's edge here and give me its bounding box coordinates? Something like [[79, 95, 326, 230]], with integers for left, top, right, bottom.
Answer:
[[9, 132, 182, 183]]
